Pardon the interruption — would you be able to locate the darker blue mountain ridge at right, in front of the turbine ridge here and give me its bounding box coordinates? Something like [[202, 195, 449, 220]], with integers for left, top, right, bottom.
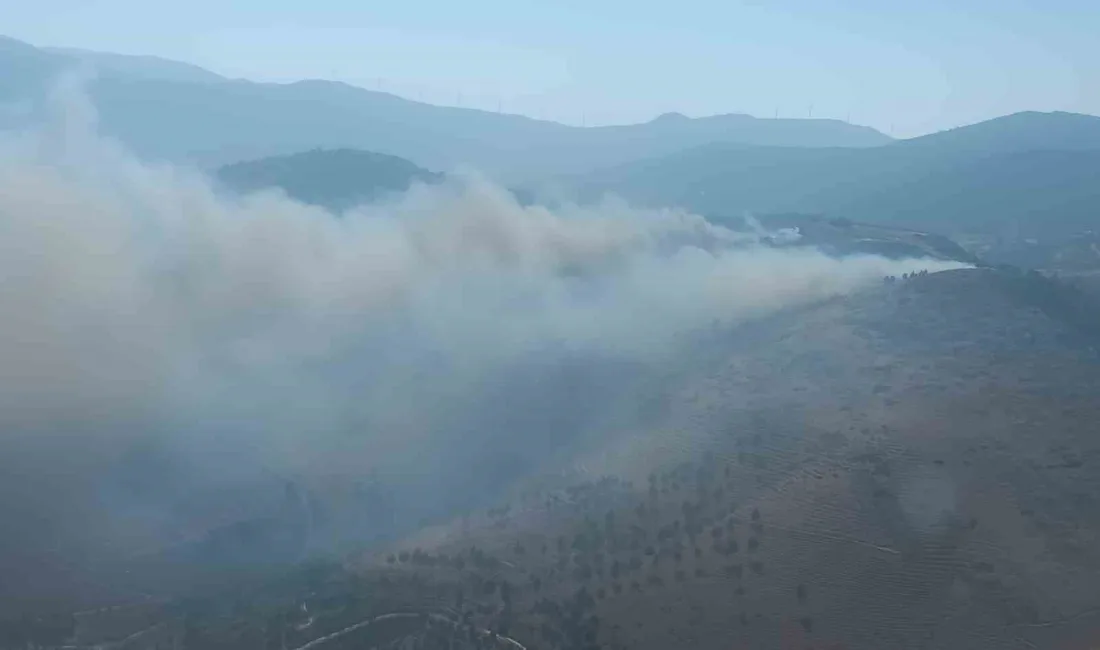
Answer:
[[572, 112, 1100, 243]]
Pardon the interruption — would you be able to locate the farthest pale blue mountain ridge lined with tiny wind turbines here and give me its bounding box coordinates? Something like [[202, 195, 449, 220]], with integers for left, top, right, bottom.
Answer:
[[0, 38, 890, 181]]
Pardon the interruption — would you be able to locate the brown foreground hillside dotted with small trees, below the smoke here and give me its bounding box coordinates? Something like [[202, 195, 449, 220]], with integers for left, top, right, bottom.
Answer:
[[19, 269, 1100, 650]]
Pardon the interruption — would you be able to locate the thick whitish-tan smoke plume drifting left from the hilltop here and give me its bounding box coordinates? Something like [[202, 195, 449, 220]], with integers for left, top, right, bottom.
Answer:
[[0, 86, 963, 611]]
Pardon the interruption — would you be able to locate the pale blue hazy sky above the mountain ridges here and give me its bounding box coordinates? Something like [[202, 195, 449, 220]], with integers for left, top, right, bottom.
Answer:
[[0, 0, 1100, 136]]
